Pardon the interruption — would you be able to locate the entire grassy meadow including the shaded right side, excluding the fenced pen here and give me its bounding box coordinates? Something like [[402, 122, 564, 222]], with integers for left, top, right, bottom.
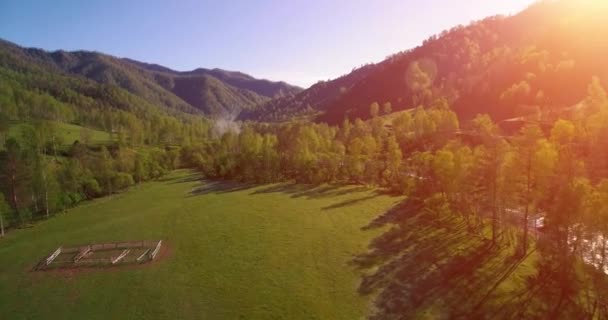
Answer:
[[0, 171, 576, 319]]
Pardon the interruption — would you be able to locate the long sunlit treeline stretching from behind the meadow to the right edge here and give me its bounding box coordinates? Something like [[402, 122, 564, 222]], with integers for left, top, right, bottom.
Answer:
[[181, 78, 608, 316]]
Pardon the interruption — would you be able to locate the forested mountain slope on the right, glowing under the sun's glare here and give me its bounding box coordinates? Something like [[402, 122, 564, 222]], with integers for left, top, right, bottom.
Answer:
[[242, 0, 608, 123]]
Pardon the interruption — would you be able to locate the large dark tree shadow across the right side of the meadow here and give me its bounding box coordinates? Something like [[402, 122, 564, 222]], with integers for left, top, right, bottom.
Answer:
[[351, 200, 531, 319]]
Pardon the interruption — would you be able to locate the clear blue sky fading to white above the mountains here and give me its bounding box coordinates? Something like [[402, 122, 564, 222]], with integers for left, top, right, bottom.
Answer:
[[0, 0, 533, 87]]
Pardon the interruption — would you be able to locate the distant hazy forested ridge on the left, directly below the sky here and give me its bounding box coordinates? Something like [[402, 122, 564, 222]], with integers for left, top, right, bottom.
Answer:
[[0, 41, 301, 116]]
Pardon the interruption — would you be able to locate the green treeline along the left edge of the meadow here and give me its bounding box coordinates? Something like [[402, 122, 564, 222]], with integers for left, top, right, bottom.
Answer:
[[0, 121, 185, 234]]
